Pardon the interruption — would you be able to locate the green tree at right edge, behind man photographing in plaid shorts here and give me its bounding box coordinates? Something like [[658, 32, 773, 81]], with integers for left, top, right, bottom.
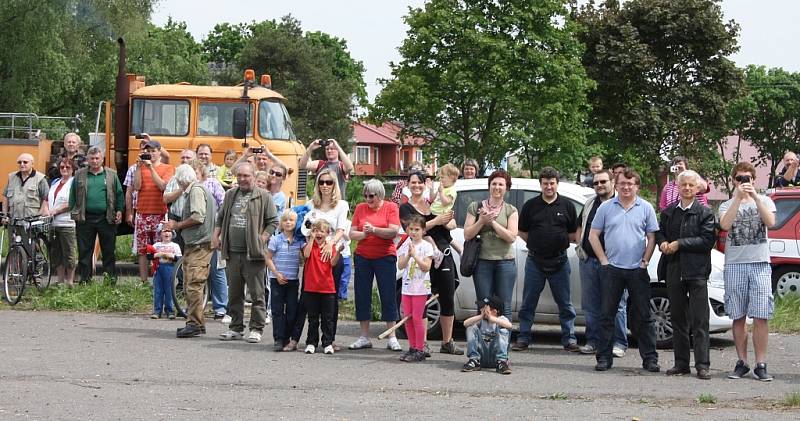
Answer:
[[732, 65, 800, 187]]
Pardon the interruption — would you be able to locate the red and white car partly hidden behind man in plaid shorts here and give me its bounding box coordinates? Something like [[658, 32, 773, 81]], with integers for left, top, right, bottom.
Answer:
[[717, 188, 800, 296]]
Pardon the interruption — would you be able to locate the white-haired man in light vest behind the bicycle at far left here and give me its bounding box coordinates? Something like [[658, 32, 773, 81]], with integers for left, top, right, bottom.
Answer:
[[3, 153, 50, 218]]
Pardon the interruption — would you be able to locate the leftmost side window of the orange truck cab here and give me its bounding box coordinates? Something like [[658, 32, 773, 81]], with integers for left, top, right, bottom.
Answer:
[[131, 98, 189, 136]]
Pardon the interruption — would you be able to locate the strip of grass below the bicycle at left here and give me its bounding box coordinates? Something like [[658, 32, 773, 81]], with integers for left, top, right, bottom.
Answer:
[[4, 280, 153, 313]]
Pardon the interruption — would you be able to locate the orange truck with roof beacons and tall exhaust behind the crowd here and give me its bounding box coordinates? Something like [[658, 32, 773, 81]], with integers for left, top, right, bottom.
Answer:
[[98, 38, 307, 206]]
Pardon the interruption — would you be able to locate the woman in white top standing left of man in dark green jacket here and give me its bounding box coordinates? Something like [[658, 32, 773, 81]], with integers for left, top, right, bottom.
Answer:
[[47, 158, 78, 287]]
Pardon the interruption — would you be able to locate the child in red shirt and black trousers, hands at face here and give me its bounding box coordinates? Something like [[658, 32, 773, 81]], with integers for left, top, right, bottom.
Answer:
[[301, 219, 339, 354]]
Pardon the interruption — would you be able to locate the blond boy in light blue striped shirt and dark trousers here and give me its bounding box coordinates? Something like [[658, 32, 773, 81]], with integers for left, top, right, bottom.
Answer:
[[266, 209, 306, 351]]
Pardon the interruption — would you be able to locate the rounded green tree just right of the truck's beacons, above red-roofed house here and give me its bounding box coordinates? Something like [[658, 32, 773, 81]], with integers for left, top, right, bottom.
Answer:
[[239, 16, 363, 148]]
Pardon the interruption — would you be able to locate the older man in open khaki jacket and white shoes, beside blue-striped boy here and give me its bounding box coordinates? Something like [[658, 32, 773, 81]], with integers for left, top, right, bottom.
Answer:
[[212, 162, 278, 343]]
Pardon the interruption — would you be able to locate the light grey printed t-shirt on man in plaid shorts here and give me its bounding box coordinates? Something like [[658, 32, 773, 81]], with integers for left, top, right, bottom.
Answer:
[[719, 194, 775, 264]]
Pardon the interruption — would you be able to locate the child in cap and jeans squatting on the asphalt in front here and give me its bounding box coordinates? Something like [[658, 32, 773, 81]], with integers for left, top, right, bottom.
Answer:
[[461, 296, 511, 374]]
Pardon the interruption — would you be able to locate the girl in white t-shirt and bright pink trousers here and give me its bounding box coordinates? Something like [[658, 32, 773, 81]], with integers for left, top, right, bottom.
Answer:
[[397, 215, 434, 362]]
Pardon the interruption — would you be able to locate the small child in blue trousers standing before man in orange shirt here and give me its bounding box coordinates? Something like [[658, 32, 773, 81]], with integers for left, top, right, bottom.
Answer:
[[150, 224, 181, 319]]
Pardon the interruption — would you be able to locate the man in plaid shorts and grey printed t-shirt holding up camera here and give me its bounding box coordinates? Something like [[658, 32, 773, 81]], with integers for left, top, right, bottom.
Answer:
[[719, 162, 775, 381]]
